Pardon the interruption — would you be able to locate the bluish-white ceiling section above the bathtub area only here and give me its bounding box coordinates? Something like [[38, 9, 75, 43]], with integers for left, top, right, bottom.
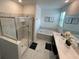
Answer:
[[37, 0, 64, 9]]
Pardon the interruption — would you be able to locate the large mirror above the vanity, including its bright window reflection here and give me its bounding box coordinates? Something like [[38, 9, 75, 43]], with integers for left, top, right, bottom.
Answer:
[[59, 3, 79, 38]]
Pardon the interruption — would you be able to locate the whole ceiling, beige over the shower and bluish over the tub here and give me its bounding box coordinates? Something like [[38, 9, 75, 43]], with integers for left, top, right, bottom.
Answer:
[[14, 0, 70, 9]]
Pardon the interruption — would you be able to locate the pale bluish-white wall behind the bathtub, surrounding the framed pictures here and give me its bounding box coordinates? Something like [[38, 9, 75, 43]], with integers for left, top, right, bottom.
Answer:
[[41, 9, 60, 29]]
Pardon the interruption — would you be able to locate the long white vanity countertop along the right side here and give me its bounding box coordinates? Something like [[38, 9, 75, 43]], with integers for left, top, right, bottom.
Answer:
[[53, 32, 79, 59]]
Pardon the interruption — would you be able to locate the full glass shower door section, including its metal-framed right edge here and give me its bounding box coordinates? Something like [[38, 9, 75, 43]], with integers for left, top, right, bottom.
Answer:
[[16, 17, 33, 46]]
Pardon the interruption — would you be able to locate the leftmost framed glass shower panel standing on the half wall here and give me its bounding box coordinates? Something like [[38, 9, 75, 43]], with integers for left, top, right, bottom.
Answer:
[[0, 17, 17, 40]]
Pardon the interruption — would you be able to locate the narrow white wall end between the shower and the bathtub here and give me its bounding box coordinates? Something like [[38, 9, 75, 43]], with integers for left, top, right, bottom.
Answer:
[[34, 4, 41, 40]]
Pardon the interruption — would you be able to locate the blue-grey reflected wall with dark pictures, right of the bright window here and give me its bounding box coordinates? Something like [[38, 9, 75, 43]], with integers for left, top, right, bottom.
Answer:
[[63, 15, 79, 38]]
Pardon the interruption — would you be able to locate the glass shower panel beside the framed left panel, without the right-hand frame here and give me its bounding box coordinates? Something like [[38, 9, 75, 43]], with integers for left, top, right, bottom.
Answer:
[[16, 17, 29, 40]]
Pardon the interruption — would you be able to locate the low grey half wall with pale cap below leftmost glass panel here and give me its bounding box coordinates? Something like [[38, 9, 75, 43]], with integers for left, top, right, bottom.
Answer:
[[0, 36, 28, 59]]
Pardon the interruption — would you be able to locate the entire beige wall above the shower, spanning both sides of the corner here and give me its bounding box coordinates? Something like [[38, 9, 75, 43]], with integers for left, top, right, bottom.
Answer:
[[0, 0, 35, 16]]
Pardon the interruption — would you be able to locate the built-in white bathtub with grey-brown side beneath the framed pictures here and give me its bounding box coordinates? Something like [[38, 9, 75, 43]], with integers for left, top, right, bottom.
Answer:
[[37, 29, 53, 41]]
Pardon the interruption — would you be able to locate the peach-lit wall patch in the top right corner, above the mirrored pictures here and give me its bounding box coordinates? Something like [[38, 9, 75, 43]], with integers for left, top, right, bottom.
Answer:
[[67, 0, 79, 15]]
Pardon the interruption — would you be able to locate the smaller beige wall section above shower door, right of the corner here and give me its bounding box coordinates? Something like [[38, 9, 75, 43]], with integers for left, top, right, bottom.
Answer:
[[23, 4, 35, 16]]
